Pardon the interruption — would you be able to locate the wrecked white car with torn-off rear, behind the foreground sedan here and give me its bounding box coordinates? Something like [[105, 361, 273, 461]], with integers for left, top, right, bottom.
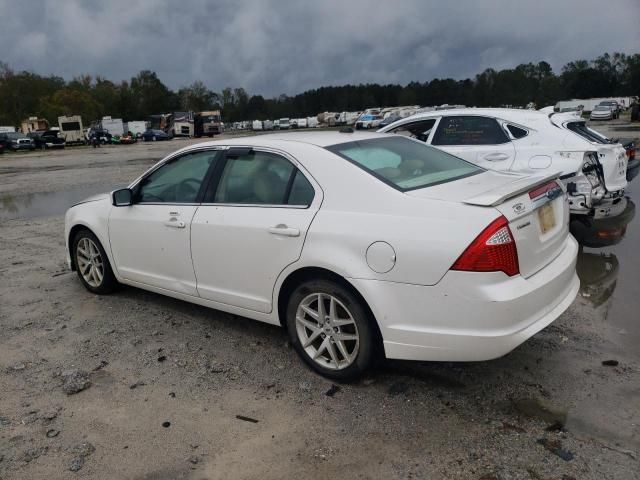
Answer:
[[379, 108, 627, 221]]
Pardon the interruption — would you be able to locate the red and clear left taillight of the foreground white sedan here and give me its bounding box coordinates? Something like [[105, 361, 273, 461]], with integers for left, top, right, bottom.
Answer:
[[451, 216, 520, 277]]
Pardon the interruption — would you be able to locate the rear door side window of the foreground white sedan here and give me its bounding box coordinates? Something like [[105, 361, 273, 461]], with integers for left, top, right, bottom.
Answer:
[[213, 151, 313, 206]]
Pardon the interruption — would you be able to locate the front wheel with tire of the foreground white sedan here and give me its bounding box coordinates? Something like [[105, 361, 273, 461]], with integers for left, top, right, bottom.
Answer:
[[71, 229, 119, 295]]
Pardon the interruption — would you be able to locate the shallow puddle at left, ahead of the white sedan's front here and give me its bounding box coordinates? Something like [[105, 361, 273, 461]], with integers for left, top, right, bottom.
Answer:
[[0, 185, 117, 220]]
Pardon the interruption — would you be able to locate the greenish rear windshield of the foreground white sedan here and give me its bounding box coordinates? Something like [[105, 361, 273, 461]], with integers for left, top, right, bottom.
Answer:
[[327, 136, 484, 192]]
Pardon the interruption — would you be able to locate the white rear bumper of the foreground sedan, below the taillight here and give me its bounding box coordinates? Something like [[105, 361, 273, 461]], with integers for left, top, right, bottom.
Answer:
[[351, 235, 580, 361]]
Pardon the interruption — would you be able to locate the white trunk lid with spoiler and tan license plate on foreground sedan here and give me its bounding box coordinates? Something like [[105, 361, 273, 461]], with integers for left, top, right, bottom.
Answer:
[[407, 171, 569, 278]]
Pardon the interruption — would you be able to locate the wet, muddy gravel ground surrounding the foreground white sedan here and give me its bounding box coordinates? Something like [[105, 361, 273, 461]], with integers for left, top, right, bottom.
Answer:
[[0, 128, 640, 480]]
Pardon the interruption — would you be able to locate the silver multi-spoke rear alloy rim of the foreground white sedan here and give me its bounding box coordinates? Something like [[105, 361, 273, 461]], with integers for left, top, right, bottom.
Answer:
[[296, 293, 360, 370]]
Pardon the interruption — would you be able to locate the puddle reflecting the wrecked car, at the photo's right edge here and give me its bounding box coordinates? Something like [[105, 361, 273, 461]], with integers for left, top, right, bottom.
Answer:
[[577, 186, 640, 357]]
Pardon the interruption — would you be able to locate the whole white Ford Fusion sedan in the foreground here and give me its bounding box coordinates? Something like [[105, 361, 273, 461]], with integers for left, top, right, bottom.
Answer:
[[65, 132, 579, 379]]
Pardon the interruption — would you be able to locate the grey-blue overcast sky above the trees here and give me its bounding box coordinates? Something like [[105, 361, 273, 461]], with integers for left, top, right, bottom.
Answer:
[[0, 0, 640, 96]]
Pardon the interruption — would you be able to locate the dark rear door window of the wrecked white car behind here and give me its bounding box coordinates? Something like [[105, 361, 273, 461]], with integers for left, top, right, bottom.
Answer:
[[431, 115, 509, 145]]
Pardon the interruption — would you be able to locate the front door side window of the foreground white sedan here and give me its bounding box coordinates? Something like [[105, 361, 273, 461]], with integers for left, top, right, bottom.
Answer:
[[135, 150, 218, 203]]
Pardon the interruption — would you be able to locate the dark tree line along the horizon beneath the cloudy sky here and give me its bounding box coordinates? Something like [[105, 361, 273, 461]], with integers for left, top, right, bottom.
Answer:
[[0, 53, 640, 125]]
